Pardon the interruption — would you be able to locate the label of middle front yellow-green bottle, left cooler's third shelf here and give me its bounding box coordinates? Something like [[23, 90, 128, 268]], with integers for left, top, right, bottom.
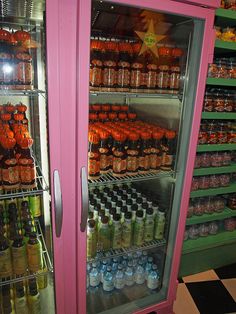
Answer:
[[11, 245, 27, 275]]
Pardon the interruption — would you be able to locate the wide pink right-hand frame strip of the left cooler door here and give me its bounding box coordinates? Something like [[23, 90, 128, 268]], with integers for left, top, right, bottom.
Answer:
[[46, 0, 77, 314]]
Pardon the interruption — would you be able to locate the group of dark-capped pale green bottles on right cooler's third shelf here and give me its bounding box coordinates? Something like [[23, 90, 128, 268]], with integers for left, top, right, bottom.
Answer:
[[87, 185, 165, 258]]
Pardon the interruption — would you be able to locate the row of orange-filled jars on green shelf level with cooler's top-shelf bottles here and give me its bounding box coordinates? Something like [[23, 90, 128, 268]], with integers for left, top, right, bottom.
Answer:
[[208, 58, 236, 79]]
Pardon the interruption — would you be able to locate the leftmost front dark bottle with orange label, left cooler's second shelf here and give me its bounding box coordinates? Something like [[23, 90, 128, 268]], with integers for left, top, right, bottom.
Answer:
[[1, 149, 20, 190]]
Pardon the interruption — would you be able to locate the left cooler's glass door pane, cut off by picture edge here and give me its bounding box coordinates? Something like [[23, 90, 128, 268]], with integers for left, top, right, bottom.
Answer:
[[0, 1, 55, 314]]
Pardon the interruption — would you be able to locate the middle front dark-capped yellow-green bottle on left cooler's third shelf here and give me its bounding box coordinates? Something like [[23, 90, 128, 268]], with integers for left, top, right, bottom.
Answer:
[[11, 235, 28, 275]]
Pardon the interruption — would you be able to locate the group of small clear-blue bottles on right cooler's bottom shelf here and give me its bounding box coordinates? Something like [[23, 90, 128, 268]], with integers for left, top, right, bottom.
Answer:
[[87, 251, 160, 292]]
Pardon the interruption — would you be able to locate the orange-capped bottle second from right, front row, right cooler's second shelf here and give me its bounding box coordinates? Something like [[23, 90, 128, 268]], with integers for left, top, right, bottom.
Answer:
[[150, 131, 164, 171]]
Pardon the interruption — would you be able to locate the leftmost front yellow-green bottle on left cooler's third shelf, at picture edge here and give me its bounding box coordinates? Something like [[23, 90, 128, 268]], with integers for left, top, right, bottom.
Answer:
[[0, 235, 12, 278]]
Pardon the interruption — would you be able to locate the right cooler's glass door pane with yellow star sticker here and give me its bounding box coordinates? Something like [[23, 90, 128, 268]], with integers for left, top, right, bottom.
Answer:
[[87, 0, 207, 314]]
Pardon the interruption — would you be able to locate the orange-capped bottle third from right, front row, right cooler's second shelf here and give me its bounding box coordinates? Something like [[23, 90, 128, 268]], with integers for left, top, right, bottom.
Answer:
[[139, 132, 151, 173]]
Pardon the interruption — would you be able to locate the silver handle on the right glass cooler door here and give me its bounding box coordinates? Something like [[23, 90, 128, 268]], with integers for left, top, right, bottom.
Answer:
[[80, 167, 89, 232]]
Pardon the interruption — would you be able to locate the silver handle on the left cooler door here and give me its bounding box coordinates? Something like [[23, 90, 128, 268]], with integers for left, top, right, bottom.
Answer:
[[53, 170, 63, 238]]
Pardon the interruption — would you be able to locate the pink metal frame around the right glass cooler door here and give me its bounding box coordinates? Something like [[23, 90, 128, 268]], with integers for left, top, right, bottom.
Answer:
[[76, 0, 217, 314]]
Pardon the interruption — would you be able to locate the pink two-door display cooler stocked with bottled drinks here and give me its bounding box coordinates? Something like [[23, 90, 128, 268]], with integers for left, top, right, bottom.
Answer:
[[0, 0, 219, 314]]
